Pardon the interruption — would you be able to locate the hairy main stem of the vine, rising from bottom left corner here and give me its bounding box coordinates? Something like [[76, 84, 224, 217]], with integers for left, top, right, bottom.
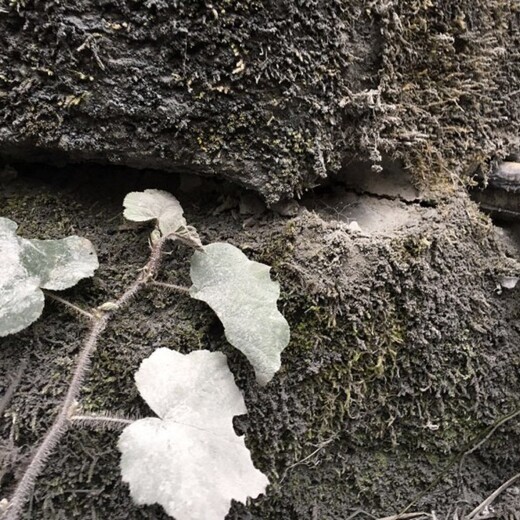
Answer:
[[0, 237, 166, 520]]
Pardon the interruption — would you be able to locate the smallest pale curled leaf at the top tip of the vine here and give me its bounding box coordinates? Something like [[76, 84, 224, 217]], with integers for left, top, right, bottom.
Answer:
[[123, 190, 186, 236]]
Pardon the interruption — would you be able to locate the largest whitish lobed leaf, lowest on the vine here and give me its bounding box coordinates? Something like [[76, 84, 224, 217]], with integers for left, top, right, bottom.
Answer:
[[118, 348, 269, 520]]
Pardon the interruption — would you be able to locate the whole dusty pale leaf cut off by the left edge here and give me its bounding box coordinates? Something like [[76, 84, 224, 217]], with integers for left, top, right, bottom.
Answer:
[[0, 217, 98, 336]]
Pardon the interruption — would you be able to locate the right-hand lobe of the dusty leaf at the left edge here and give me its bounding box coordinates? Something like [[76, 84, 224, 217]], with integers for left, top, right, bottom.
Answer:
[[21, 236, 99, 291]]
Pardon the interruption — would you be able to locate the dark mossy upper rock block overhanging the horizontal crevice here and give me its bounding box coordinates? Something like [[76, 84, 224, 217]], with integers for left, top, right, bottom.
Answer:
[[0, 0, 520, 202]]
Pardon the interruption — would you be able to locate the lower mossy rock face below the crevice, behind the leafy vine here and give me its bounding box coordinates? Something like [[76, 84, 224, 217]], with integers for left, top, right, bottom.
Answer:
[[0, 172, 520, 520]]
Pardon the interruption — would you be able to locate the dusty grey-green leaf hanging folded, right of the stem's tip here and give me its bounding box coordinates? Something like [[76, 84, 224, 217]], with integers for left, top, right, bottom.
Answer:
[[190, 242, 290, 384]]
